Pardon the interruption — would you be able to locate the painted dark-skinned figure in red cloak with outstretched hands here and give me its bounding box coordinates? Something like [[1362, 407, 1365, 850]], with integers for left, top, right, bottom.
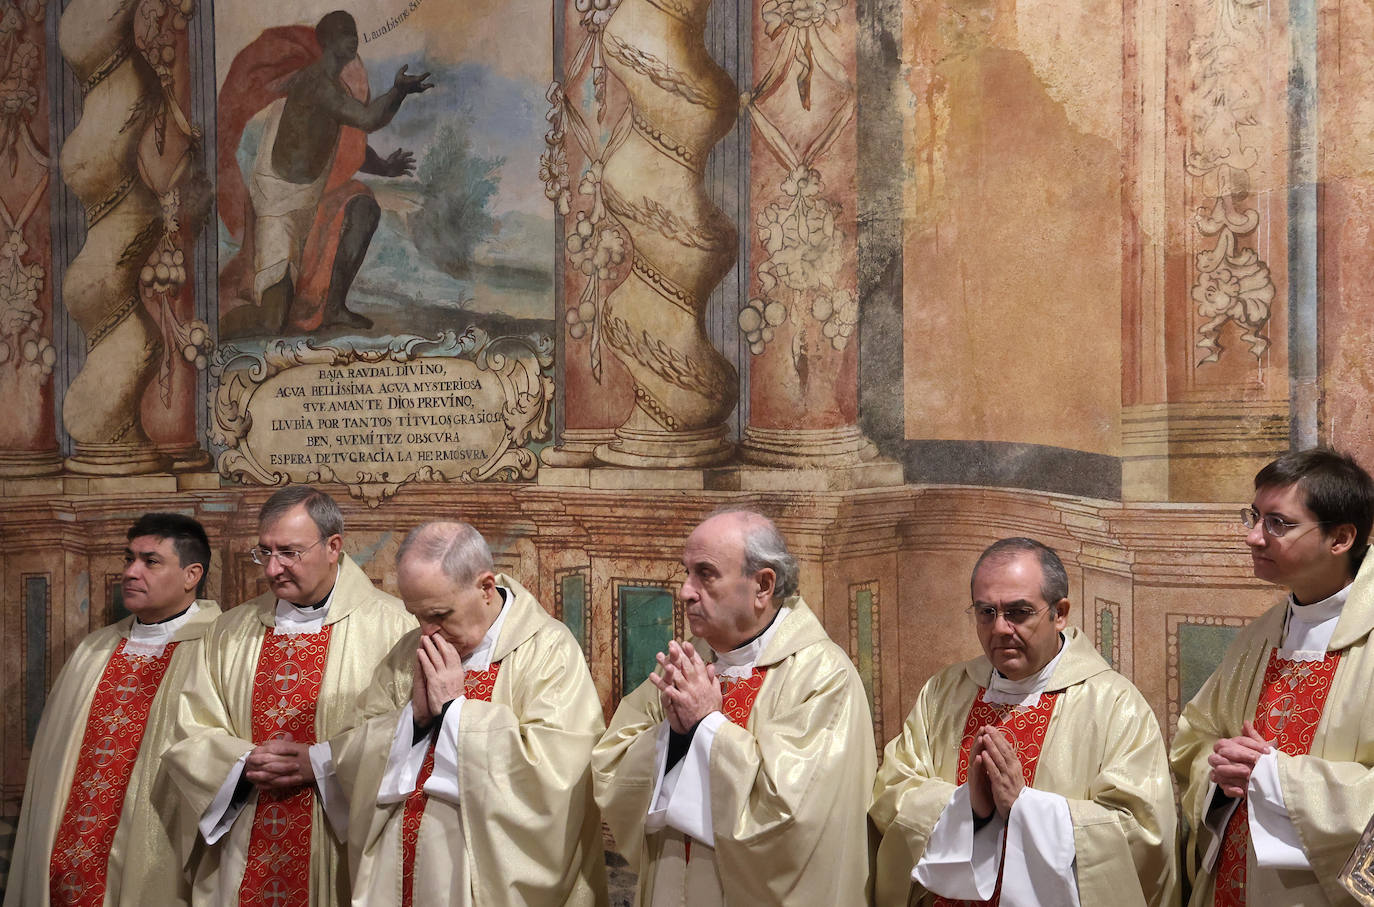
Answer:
[[220, 10, 433, 337]]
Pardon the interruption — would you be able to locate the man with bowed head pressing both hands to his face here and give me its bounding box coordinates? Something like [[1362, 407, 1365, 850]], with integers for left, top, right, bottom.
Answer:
[[333, 522, 606, 907]]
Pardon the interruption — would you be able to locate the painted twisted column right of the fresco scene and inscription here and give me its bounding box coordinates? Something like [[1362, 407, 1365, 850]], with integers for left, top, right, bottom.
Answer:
[[596, 0, 739, 467]]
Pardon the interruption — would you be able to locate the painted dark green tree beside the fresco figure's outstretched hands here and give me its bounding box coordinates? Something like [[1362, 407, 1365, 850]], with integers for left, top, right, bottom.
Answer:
[[408, 124, 506, 278]]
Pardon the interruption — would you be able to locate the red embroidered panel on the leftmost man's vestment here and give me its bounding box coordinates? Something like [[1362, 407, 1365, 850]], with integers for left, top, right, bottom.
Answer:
[[48, 639, 177, 907]]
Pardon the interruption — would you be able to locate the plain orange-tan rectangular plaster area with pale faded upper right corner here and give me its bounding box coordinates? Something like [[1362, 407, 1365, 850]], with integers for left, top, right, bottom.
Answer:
[[903, 0, 1123, 455]]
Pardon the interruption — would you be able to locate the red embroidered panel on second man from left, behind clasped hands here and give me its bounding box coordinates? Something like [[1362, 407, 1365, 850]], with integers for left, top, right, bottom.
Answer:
[[239, 625, 334, 907]]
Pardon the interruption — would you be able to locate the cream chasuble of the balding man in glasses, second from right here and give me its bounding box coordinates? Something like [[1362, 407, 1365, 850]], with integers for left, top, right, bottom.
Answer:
[[868, 628, 1179, 907]]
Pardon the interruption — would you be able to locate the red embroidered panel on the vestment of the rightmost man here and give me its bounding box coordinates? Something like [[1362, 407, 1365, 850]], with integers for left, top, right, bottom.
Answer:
[[1212, 649, 1341, 907]]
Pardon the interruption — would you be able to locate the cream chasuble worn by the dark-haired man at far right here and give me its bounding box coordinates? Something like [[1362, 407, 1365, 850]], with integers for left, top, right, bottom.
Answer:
[[1169, 555, 1374, 907]]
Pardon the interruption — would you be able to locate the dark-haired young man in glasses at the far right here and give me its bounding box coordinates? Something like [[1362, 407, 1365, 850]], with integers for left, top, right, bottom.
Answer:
[[1171, 448, 1374, 907]]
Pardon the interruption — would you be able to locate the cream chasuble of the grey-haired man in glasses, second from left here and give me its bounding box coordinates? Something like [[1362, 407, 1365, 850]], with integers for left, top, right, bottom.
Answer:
[[164, 555, 415, 907]]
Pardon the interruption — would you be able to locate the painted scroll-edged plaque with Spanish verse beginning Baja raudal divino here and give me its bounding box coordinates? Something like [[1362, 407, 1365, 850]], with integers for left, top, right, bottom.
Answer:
[[212, 328, 552, 503]]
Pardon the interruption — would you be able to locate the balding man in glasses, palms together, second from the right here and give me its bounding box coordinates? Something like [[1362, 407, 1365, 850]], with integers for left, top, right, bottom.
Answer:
[[870, 539, 1179, 907]]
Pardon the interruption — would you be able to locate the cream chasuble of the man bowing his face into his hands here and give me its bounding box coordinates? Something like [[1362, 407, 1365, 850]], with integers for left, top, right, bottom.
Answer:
[[334, 574, 606, 907]]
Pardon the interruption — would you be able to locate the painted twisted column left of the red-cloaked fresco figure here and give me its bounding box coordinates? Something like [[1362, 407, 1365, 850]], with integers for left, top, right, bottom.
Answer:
[[58, 0, 168, 475]]
